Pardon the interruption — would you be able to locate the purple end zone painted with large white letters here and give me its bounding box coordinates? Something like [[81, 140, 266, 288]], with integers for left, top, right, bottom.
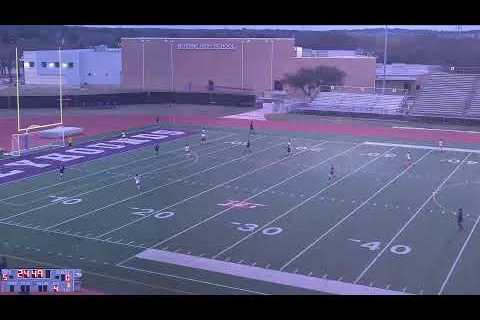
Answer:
[[0, 129, 193, 185]]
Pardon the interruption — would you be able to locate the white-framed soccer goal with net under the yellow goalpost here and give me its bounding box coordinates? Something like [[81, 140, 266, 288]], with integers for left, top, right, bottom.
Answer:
[[9, 126, 65, 156]]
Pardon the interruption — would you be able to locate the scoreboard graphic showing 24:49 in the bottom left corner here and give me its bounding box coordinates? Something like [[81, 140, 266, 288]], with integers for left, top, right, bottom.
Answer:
[[0, 269, 82, 294]]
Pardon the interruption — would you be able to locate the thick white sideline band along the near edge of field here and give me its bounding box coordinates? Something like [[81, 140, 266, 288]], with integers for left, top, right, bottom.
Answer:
[[135, 249, 405, 295]]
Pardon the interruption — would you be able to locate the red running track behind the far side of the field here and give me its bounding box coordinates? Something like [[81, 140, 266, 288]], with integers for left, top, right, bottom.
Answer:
[[0, 114, 480, 150]]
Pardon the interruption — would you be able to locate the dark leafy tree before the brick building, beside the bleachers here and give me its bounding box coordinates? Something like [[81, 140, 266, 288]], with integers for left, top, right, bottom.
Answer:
[[283, 66, 346, 97]]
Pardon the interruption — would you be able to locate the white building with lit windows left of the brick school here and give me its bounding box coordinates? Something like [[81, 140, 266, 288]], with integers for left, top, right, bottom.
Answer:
[[23, 46, 122, 87]]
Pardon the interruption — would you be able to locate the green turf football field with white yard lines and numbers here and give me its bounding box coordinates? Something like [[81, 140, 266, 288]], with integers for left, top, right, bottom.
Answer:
[[0, 125, 480, 294]]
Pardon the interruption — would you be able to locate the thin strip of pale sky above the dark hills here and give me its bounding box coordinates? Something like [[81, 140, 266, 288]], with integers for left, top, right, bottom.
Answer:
[[78, 25, 480, 31]]
